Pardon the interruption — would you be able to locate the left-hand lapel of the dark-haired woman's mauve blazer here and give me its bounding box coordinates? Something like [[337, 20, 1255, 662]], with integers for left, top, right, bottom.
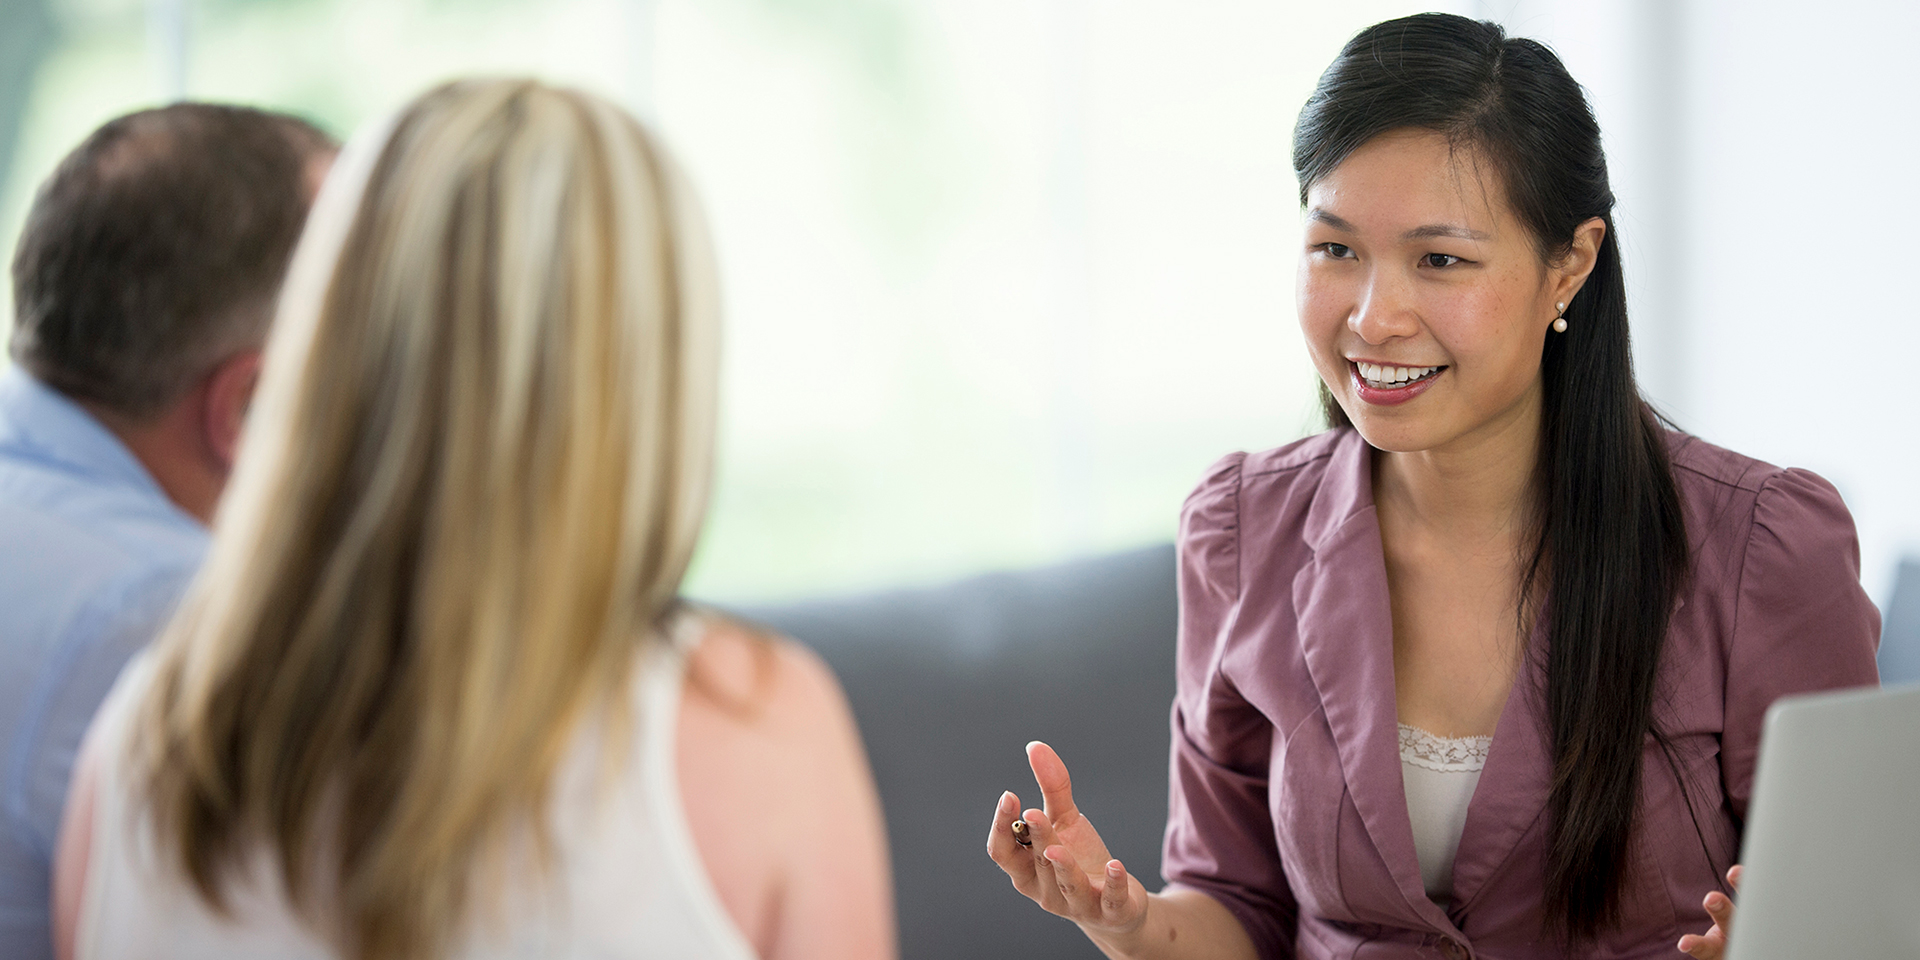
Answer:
[[1292, 432, 1446, 924]]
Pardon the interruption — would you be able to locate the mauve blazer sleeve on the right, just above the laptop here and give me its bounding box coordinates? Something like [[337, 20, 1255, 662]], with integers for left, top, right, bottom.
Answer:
[[1720, 470, 1880, 818]]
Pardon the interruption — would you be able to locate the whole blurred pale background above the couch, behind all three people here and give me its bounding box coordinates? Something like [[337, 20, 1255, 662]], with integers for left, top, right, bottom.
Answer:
[[0, 0, 1920, 609]]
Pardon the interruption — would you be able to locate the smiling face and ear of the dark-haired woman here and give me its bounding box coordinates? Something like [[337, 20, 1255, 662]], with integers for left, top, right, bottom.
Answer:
[[1300, 131, 1605, 453]]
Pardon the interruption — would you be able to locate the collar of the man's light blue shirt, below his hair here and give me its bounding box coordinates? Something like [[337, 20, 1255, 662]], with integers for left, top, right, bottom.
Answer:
[[0, 365, 171, 503]]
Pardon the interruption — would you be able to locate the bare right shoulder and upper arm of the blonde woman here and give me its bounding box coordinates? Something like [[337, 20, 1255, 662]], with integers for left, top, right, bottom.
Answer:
[[676, 616, 895, 960]]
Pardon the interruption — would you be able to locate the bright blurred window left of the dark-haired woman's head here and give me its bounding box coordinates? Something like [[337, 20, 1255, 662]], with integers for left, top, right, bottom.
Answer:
[[0, 0, 1466, 599]]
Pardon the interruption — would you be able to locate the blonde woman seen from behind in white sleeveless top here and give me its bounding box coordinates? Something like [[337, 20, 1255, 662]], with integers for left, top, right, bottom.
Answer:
[[37, 81, 895, 960]]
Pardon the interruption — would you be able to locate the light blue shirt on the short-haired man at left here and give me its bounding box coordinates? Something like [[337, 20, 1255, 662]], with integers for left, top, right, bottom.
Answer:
[[0, 367, 207, 960]]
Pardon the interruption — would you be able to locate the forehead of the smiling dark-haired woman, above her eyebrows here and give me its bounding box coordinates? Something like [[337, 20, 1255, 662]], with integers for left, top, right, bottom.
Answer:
[[1308, 131, 1517, 240]]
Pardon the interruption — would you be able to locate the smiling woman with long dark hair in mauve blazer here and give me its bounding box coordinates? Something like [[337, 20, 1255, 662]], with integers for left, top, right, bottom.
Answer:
[[989, 13, 1878, 960]]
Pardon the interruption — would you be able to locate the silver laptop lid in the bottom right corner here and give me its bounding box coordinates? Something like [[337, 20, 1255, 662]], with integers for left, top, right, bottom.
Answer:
[[1728, 685, 1920, 960]]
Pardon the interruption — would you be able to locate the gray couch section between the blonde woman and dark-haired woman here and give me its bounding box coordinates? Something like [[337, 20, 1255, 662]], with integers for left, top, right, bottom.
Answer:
[[733, 545, 1175, 960]]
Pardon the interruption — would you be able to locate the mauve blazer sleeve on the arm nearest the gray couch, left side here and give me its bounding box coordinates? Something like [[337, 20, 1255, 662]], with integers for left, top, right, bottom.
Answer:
[[1162, 455, 1300, 958]]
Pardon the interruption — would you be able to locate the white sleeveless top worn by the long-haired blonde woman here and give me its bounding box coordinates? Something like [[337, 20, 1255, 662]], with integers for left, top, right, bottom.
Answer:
[[77, 630, 755, 960]]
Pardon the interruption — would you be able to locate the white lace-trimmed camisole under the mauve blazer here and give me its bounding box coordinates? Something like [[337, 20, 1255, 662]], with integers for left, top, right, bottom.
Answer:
[[1400, 724, 1494, 906]]
